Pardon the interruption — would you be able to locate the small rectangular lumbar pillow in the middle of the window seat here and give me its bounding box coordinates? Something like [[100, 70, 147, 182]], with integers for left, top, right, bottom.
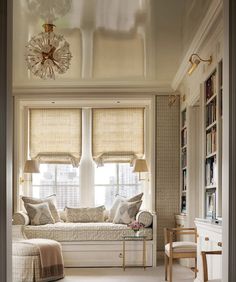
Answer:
[[66, 206, 105, 222]]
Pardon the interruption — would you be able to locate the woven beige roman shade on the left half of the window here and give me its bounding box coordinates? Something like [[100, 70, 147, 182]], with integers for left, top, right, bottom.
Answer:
[[29, 109, 82, 167]]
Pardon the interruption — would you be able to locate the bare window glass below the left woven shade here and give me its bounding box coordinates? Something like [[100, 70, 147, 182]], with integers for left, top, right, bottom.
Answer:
[[32, 164, 79, 209]]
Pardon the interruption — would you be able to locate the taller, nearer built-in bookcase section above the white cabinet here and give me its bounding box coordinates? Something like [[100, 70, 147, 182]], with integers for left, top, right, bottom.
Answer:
[[203, 61, 223, 219]]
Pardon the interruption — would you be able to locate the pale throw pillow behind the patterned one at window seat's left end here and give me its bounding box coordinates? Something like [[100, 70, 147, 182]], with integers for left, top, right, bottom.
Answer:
[[22, 194, 61, 222]]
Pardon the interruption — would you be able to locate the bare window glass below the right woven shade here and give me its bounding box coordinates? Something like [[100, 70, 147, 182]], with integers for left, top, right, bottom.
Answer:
[[95, 163, 141, 209]]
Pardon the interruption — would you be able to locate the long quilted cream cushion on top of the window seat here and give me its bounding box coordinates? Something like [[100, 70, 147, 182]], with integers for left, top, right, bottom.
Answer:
[[23, 222, 152, 242]]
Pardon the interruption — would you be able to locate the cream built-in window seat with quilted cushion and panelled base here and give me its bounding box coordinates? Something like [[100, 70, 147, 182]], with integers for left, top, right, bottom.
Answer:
[[13, 210, 156, 267]]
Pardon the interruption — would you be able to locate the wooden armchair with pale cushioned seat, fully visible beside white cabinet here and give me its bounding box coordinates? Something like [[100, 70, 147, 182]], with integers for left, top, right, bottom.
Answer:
[[164, 228, 197, 282]]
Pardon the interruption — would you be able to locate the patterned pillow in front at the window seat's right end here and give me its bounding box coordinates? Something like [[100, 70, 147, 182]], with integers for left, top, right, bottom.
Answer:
[[113, 201, 142, 224]]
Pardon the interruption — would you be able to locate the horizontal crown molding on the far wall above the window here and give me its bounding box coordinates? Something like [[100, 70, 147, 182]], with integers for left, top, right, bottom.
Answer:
[[13, 81, 173, 96]]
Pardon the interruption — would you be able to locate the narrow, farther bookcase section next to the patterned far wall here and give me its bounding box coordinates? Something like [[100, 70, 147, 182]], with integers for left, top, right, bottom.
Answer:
[[180, 108, 187, 214]]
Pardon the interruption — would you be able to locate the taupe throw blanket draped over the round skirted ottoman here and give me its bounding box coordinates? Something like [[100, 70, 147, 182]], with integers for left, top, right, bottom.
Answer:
[[25, 239, 65, 280]]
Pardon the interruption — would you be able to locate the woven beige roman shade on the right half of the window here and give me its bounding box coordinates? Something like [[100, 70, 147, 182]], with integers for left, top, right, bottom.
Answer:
[[92, 108, 144, 166]]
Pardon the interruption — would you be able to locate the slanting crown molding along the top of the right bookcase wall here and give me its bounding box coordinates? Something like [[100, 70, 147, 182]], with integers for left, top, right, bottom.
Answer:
[[171, 0, 223, 90]]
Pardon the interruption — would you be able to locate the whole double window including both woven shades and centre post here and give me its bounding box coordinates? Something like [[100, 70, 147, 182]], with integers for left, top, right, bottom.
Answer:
[[25, 108, 148, 209]]
